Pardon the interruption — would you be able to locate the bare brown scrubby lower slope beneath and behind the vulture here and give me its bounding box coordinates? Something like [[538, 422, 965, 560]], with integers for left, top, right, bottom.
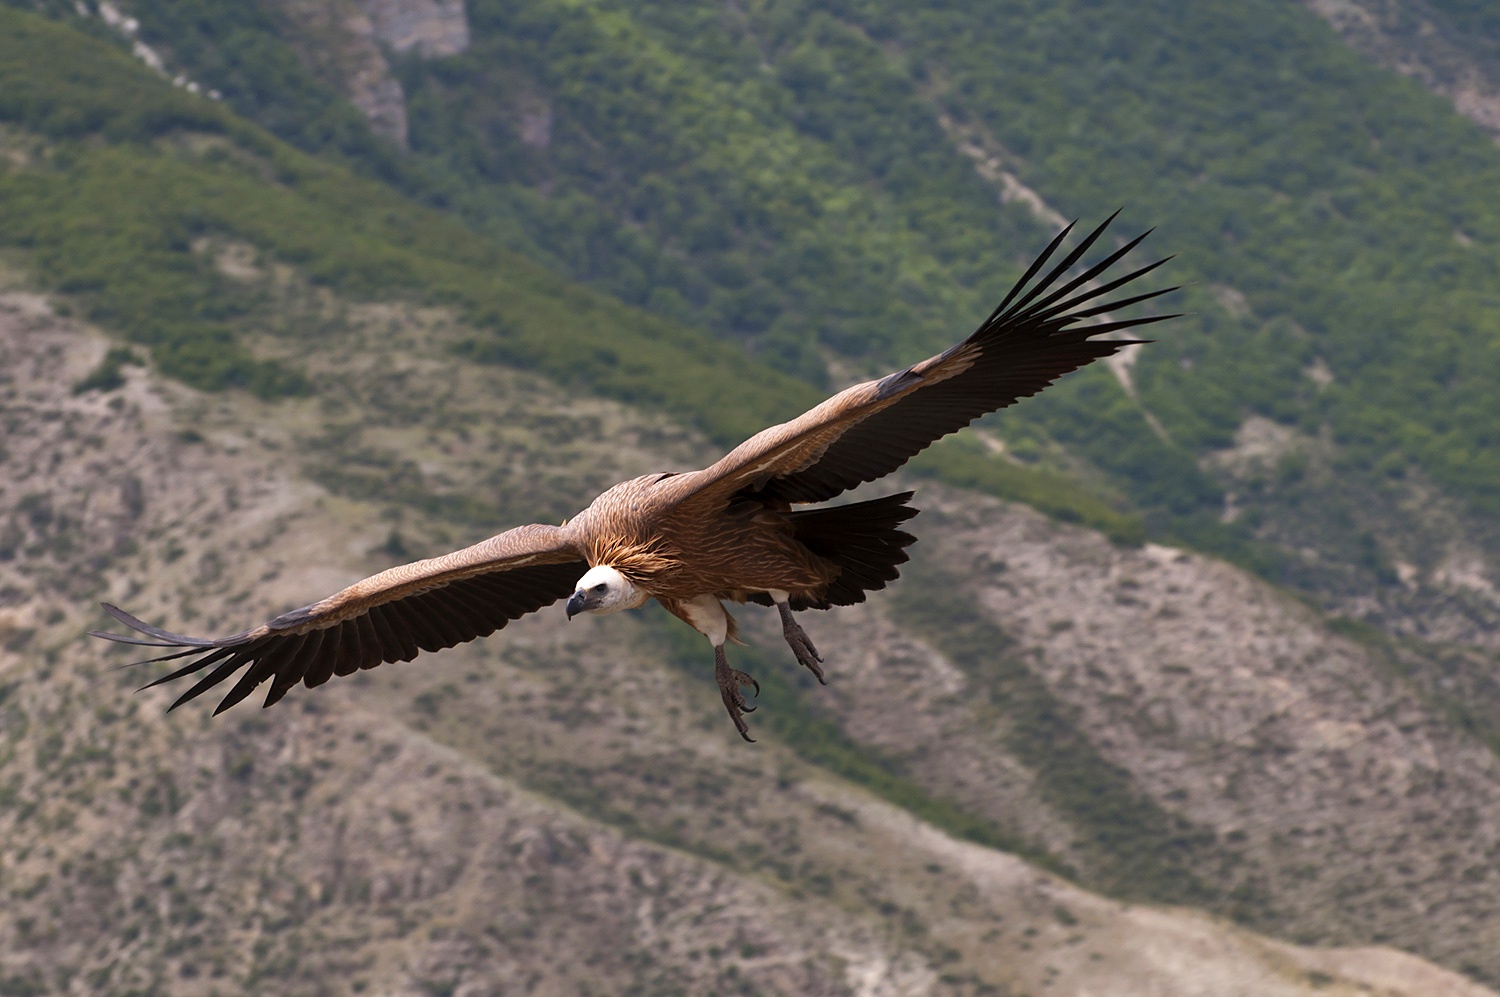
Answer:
[[0, 283, 1496, 996]]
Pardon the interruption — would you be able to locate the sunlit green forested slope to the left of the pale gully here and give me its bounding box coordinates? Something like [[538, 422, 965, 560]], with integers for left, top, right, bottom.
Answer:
[[405, 0, 1044, 375]]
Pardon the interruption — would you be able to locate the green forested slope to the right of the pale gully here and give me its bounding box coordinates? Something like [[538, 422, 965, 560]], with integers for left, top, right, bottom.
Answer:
[[861, 1, 1500, 511]]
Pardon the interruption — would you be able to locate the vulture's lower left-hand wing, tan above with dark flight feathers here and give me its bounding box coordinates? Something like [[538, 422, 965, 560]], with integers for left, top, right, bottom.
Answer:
[[90, 526, 588, 715]]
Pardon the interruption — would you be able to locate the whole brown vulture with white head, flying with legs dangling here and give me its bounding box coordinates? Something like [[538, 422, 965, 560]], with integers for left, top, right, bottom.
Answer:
[[92, 211, 1176, 741]]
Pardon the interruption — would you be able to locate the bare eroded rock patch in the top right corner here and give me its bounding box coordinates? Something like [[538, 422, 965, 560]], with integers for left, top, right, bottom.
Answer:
[[1305, 0, 1500, 141]]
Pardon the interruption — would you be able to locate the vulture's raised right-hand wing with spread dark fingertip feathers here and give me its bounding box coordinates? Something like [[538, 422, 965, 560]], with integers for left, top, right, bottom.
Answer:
[[674, 211, 1178, 502]]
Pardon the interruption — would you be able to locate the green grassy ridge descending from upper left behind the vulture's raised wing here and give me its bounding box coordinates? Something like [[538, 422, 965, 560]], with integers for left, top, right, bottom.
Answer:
[[0, 7, 1131, 537]]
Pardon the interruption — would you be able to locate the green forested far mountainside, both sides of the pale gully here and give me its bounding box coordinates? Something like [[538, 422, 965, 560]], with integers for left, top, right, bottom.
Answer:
[[384, 0, 1500, 527]]
